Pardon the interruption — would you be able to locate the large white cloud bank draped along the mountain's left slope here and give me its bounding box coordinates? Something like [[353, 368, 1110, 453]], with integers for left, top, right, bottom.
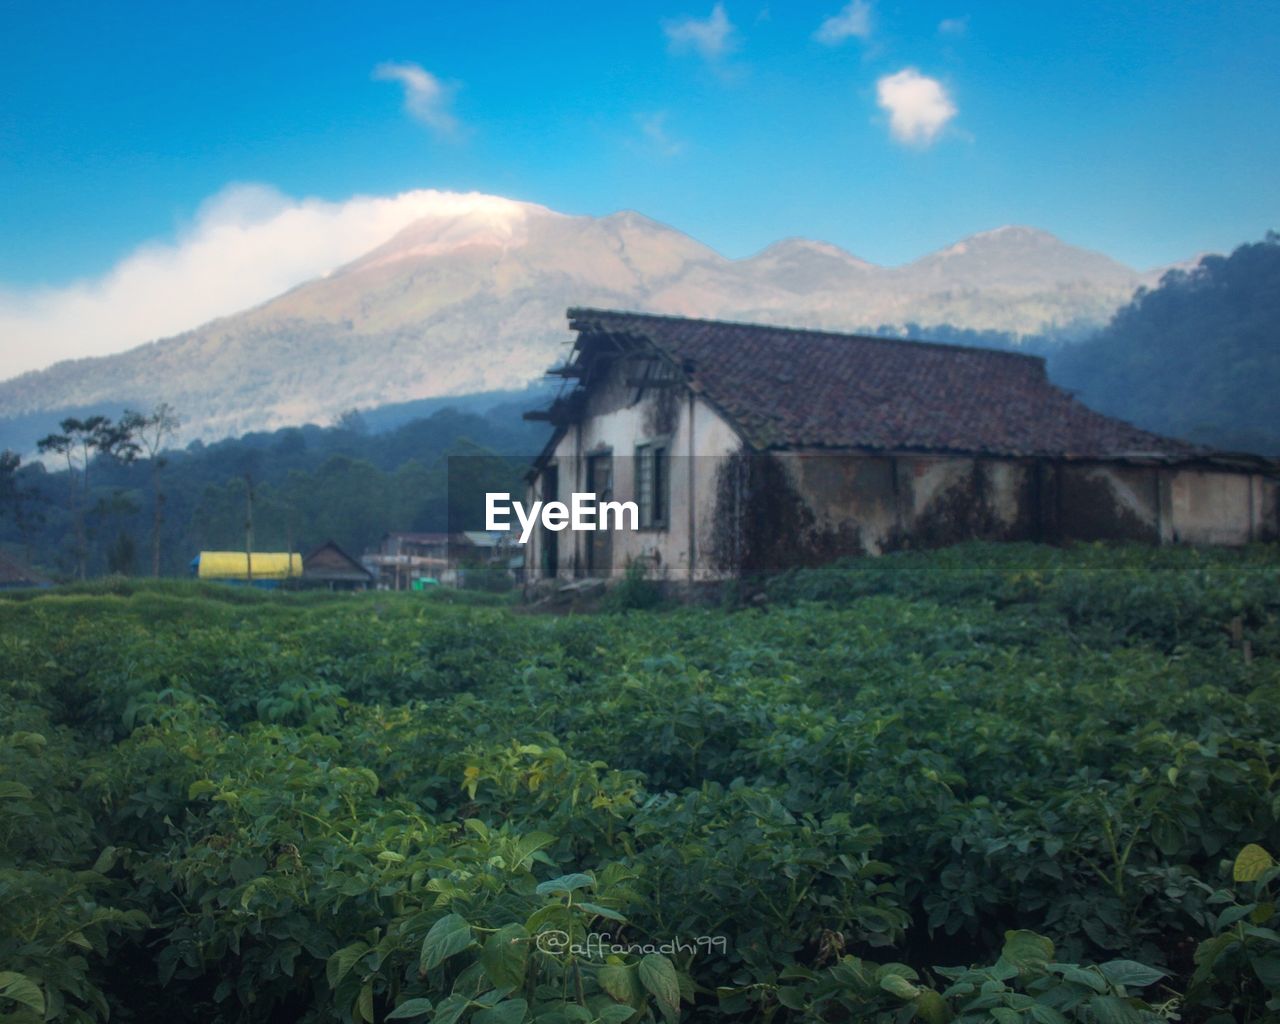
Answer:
[[0, 184, 540, 378]]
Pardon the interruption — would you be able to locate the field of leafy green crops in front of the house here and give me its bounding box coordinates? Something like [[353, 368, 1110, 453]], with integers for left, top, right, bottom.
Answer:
[[0, 547, 1280, 1024]]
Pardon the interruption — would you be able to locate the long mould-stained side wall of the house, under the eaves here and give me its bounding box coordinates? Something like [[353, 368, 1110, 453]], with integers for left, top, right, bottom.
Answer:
[[686, 452, 1280, 576]]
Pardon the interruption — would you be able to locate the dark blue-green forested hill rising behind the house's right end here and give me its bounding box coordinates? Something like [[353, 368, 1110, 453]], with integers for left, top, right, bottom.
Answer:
[[1050, 238, 1280, 454]]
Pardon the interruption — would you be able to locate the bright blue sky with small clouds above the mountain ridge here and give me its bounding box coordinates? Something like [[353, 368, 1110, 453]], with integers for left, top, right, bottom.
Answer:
[[0, 0, 1280, 294]]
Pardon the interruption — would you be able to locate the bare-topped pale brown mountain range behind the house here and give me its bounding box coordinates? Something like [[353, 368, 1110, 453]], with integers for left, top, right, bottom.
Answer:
[[0, 197, 1162, 448]]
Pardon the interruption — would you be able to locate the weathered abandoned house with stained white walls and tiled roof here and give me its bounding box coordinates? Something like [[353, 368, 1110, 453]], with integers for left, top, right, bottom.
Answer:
[[526, 308, 1280, 581]]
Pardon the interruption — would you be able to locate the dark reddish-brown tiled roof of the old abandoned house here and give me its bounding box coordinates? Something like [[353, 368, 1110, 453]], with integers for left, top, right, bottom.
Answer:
[[568, 308, 1201, 457]]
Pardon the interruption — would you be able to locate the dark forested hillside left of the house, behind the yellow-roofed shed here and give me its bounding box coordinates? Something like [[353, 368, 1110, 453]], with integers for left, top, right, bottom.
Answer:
[[0, 403, 545, 576]]
